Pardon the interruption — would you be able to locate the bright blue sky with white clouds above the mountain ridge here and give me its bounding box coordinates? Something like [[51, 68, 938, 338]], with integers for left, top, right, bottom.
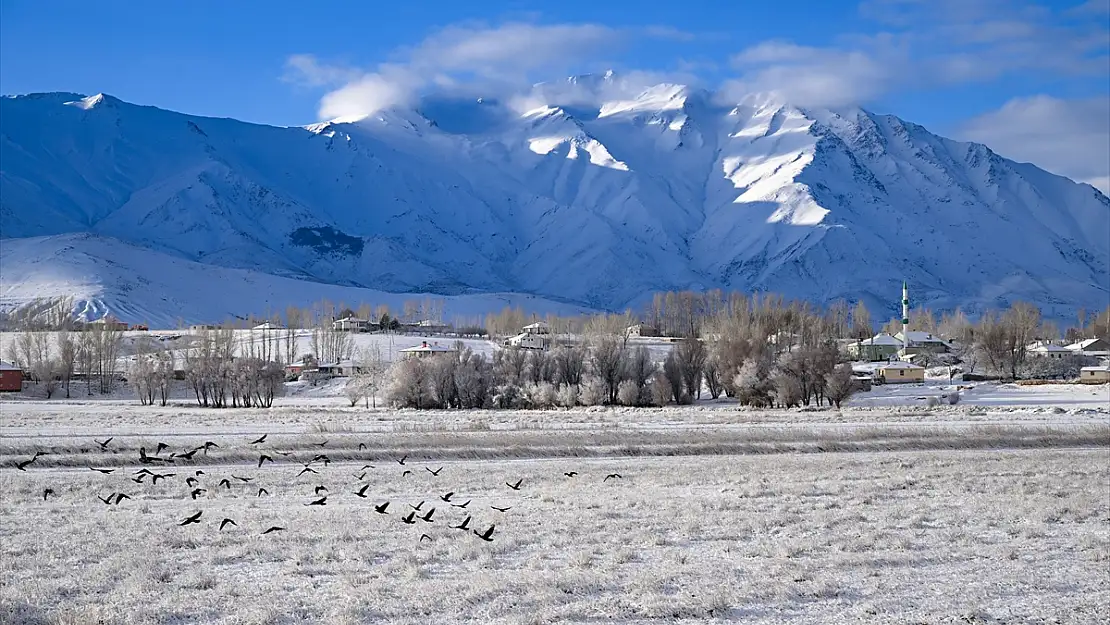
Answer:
[[0, 0, 1110, 190]]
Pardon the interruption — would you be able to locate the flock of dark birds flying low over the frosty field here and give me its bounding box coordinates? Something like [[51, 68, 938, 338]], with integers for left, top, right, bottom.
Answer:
[[16, 434, 622, 542]]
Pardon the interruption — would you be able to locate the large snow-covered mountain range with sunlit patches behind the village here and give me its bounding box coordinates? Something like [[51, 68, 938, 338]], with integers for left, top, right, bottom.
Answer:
[[0, 74, 1110, 316]]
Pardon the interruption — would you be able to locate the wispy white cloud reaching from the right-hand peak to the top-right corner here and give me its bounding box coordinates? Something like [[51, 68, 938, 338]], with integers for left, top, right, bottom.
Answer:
[[728, 0, 1110, 105]]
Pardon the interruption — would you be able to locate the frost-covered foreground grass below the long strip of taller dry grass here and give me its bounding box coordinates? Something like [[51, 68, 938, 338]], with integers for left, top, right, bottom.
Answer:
[[0, 436, 1110, 624]]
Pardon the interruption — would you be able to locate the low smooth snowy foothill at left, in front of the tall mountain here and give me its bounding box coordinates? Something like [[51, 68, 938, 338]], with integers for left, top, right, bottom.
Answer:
[[0, 233, 589, 327]]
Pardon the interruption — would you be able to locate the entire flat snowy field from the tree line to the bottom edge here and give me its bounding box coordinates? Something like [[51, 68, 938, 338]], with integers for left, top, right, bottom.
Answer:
[[0, 385, 1110, 624]]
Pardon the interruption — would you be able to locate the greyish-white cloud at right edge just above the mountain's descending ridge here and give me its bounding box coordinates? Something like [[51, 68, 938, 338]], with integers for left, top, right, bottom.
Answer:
[[957, 95, 1110, 194]]
